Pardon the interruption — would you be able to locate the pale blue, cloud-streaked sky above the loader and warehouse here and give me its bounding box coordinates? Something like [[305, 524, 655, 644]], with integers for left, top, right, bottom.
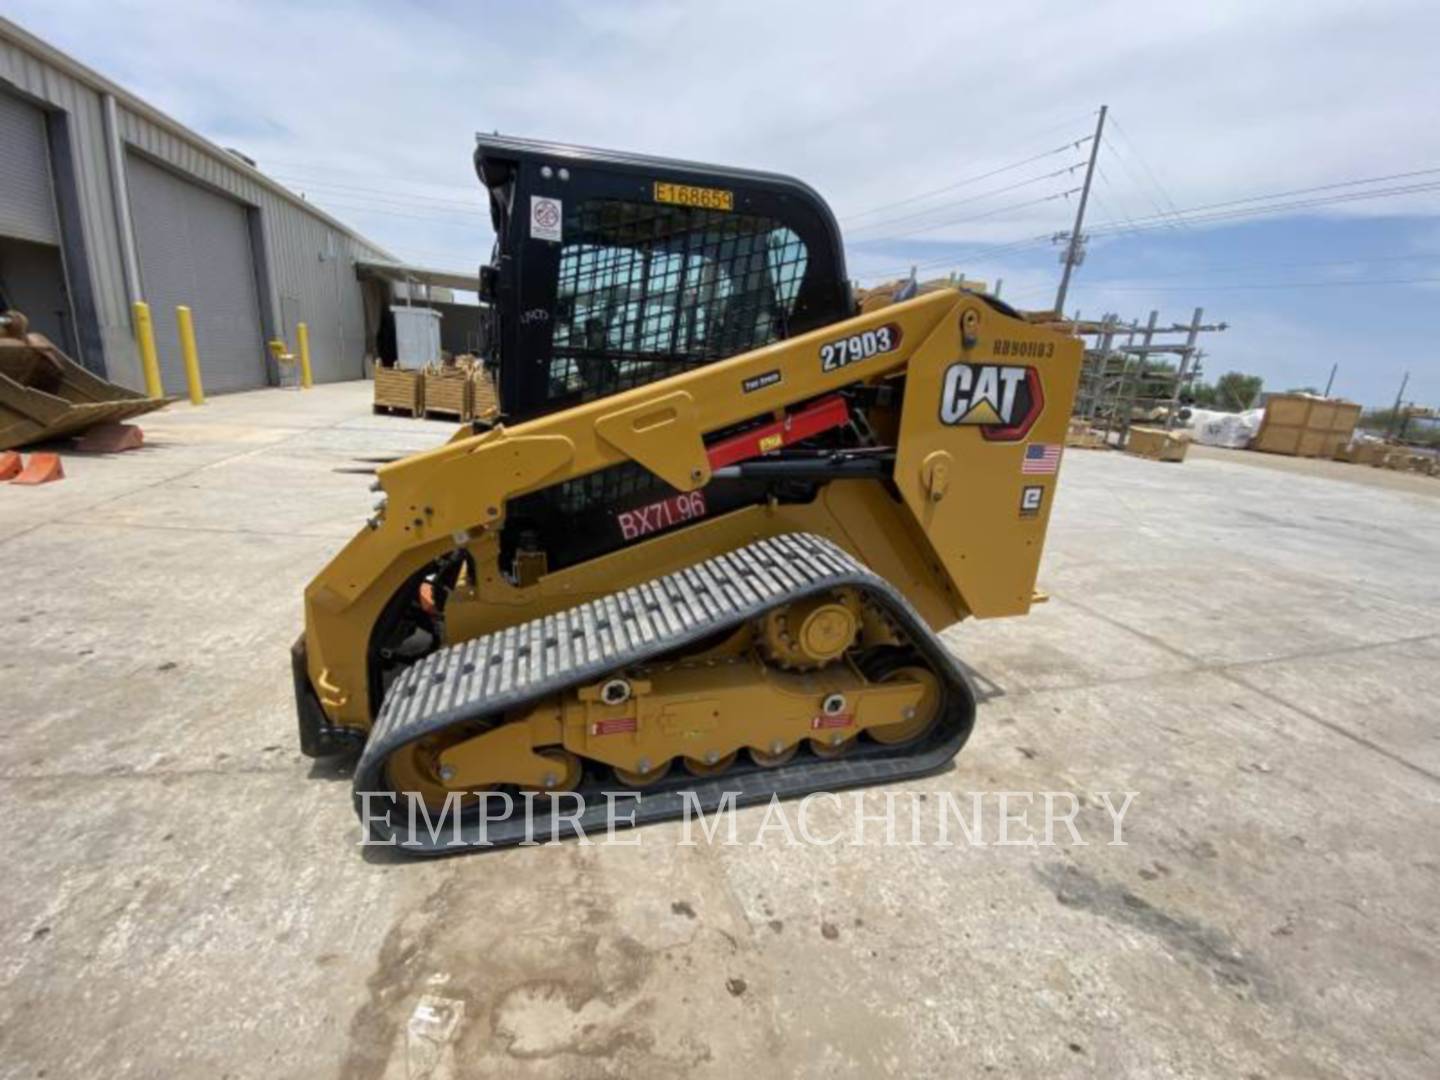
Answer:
[[6, 0, 1440, 405]]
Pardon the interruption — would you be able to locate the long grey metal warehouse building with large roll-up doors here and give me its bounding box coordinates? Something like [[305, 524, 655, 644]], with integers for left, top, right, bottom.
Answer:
[[0, 19, 454, 395]]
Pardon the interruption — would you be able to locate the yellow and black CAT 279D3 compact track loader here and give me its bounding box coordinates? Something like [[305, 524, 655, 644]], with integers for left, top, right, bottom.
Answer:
[[292, 137, 1081, 852]]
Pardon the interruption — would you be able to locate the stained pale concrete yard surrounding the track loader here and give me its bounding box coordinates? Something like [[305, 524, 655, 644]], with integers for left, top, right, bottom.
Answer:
[[0, 383, 1440, 1077]]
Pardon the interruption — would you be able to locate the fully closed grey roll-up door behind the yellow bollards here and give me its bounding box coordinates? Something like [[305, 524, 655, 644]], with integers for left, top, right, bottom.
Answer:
[[125, 154, 266, 395]]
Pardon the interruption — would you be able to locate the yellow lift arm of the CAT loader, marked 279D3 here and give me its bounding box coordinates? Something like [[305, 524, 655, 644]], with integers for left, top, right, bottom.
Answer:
[[305, 289, 1080, 726]]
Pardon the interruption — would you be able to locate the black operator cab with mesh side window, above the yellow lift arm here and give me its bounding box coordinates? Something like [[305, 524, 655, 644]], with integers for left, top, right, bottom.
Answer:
[[475, 135, 852, 423]]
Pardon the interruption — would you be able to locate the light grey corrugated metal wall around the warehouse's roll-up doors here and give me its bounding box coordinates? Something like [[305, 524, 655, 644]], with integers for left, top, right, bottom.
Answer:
[[0, 20, 387, 389]]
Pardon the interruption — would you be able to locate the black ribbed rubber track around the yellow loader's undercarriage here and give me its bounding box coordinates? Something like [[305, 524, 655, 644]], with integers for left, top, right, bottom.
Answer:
[[353, 533, 975, 854]]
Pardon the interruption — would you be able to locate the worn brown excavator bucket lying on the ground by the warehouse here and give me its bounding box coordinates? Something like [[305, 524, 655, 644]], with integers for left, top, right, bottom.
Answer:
[[0, 311, 171, 451]]
